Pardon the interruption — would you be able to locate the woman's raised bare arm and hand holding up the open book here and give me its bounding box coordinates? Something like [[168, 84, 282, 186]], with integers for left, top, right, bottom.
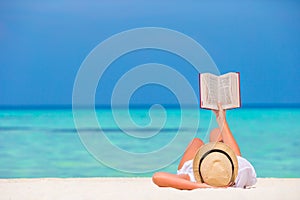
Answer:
[[214, 103, 241, 156]]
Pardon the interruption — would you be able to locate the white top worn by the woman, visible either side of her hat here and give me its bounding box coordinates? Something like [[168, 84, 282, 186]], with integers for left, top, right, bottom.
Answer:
[[177, 156, 256, 188]]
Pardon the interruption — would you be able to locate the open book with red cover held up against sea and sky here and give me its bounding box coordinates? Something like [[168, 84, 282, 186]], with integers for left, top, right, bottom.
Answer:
[[199, 72, 241, 110]]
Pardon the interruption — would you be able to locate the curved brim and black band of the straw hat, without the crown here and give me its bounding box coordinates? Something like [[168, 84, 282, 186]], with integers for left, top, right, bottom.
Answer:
[[193, 142, 238, 184]]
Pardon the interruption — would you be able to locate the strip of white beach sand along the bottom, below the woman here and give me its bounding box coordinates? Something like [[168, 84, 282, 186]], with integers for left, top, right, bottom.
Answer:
[[0, 178, 300, 200]]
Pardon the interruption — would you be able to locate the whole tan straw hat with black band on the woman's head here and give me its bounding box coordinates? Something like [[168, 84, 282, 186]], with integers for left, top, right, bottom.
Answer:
[[193, 142, 238, 187]]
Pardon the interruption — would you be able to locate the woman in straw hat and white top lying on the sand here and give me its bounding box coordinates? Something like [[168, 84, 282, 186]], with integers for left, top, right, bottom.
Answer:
[[152, 104, 256, 190]]
